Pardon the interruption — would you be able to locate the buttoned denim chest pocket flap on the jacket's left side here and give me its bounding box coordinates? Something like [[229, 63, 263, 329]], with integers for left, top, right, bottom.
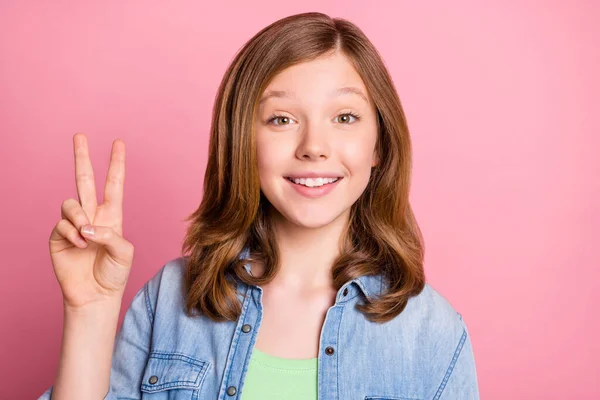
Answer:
[[141, 351, 210, 399]]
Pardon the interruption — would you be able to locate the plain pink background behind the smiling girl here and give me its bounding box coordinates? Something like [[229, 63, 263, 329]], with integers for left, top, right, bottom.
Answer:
[[0, 0, 600, 400]]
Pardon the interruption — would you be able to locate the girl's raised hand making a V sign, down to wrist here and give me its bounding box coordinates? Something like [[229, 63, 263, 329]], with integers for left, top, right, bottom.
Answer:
[[49, 133, 134, 309]]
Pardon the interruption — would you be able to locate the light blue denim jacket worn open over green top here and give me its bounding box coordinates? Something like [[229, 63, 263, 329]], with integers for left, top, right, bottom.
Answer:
[[39, 250, 479, 400]]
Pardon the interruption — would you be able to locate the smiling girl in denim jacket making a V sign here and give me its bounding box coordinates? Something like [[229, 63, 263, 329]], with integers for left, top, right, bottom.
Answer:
[[40, 13, 479, 400]]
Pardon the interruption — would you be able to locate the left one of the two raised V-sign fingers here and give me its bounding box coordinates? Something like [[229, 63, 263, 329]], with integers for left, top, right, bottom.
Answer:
[[73, 133, 98, 221]]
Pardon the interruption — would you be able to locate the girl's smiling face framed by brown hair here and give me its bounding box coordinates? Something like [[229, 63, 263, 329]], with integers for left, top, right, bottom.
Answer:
[[255, 53, 377, 228]]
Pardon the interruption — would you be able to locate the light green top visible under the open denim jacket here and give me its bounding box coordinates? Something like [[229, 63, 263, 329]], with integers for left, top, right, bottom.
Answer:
[[240, 348, 318, 400]]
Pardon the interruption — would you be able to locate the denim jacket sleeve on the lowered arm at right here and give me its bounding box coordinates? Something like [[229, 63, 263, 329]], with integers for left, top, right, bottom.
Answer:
[[433, 314, 479, 400]]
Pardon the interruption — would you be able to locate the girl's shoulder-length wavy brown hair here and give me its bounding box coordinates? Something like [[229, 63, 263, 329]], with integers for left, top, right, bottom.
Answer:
[[182, 12, 425, 322]]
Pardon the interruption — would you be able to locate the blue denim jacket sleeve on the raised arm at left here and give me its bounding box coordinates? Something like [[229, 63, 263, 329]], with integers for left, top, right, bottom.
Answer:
[[38, 271, 162, 400]]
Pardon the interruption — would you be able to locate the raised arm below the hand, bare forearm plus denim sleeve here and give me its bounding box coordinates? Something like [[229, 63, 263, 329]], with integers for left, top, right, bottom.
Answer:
[[38, 274, 160, 400]]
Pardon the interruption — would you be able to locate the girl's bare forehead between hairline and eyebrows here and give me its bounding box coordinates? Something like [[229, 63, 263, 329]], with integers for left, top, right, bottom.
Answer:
[[260, 53, 370, 105]]
